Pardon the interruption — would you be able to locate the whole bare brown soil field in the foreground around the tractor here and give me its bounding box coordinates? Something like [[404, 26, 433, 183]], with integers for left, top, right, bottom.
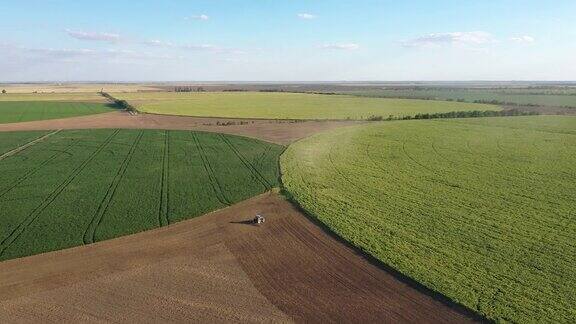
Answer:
[[0, 193, 473, 323]]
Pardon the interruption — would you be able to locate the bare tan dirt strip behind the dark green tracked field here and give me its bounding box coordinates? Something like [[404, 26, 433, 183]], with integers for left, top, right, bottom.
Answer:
[[0, 112, 360, 144]]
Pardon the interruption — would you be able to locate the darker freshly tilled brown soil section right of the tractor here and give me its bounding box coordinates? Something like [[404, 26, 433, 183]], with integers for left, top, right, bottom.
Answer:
[[226, 194, 474, 323]]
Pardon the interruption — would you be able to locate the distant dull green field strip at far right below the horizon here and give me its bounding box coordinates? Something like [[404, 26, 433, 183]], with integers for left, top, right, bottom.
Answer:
[[344, 88, 576, 108]]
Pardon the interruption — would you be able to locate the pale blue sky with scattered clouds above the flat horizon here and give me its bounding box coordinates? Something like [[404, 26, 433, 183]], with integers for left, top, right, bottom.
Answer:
[[0, 0, 576, 82]]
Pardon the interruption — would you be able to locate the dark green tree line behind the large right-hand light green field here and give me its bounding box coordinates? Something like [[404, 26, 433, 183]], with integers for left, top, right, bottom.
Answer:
[[366, 109, 539, 121]]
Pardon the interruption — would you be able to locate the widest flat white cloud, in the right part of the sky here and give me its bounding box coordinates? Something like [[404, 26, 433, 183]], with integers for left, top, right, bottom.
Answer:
[[402, 31, 495, 48]]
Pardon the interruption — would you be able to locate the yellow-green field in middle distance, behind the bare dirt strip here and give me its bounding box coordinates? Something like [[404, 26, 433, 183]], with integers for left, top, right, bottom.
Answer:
[[113, 92, 499, 119]]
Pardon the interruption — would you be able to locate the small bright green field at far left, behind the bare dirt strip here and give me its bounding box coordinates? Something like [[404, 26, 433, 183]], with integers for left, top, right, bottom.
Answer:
[[0, 100, 117, 124]]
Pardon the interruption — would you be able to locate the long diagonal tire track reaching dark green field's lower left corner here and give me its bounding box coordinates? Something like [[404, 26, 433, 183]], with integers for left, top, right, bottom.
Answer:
[[0, 130, 120, 257]]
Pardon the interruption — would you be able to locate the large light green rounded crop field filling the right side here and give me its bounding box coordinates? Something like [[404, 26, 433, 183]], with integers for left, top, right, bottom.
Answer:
[[281, 116, 576, 323]]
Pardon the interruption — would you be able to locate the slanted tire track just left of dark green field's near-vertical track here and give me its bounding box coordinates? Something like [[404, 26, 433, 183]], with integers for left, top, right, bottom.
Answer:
[[83, 130, 144, 244]]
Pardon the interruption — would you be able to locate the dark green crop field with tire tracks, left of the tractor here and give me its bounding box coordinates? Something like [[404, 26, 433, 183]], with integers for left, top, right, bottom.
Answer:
[[0, 130, 283, 260]]
